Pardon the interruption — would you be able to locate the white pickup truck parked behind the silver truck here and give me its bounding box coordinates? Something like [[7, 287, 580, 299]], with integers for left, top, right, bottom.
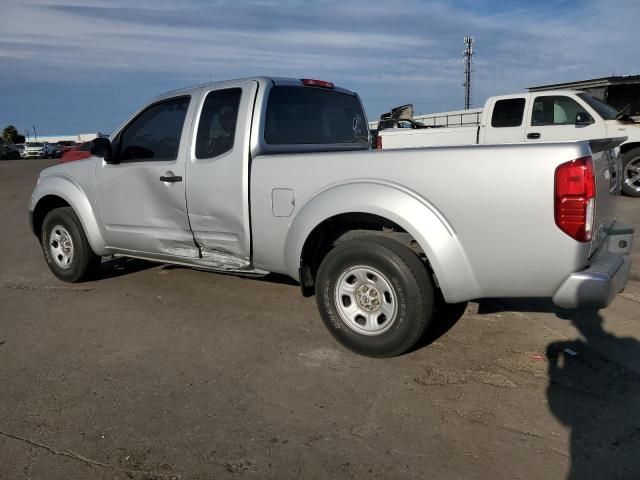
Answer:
[[378, 90, 640, 197]]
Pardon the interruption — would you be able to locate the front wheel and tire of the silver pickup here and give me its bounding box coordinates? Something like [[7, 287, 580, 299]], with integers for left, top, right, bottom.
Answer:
[[40, 207, 101, 282]]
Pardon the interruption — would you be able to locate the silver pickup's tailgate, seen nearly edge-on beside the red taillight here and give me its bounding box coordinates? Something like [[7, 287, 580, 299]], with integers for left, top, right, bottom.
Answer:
[[589, 137, 626, 256]]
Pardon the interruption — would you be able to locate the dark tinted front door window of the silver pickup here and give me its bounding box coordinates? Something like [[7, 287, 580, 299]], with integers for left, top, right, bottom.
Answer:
[[118, 97, 190, 162]]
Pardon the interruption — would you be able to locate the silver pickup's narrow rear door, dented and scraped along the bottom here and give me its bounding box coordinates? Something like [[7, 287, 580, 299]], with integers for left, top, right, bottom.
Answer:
[[186, 80, 258, 270]]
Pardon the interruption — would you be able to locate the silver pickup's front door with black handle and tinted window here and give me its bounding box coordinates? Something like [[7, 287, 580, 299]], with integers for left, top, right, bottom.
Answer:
[[95, 95, 197, 258]]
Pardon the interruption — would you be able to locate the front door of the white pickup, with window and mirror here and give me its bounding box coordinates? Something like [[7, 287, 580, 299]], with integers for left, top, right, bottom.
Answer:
[[524, 92, 607, 142]]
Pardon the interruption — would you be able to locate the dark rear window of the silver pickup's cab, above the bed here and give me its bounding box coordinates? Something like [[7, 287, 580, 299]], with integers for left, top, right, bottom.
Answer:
[[264, 85, 369, 150]]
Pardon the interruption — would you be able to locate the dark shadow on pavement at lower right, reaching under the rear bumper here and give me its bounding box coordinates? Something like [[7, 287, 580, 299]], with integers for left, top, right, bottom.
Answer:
[[479, 299, 640, 480]]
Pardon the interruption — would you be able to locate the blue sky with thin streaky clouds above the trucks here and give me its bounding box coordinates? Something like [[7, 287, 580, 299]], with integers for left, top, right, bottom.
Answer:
[[0, 0, 640, 135]]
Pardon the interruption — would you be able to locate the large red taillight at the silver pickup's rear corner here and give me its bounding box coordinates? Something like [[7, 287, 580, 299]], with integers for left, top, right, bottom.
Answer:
[[555, 157, 596, 242]]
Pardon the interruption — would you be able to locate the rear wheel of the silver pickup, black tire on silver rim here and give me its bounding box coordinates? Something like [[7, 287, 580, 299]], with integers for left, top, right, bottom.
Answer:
[[316, 236, 434, 357]]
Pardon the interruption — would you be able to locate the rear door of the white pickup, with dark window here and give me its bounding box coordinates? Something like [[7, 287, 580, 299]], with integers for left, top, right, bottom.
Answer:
[[480, 94, 528, 144]]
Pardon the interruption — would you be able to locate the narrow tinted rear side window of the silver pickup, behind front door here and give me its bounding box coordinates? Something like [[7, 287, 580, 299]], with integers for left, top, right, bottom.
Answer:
[[196, 88, 242, 158]]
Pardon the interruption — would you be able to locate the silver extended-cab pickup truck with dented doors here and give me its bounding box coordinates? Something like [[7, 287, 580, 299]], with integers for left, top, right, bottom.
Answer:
[[30, 78, 633, 356]]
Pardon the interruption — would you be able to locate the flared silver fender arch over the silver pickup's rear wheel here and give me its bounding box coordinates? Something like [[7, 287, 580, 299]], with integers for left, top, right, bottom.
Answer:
[[285, 181, 480, 302]]
